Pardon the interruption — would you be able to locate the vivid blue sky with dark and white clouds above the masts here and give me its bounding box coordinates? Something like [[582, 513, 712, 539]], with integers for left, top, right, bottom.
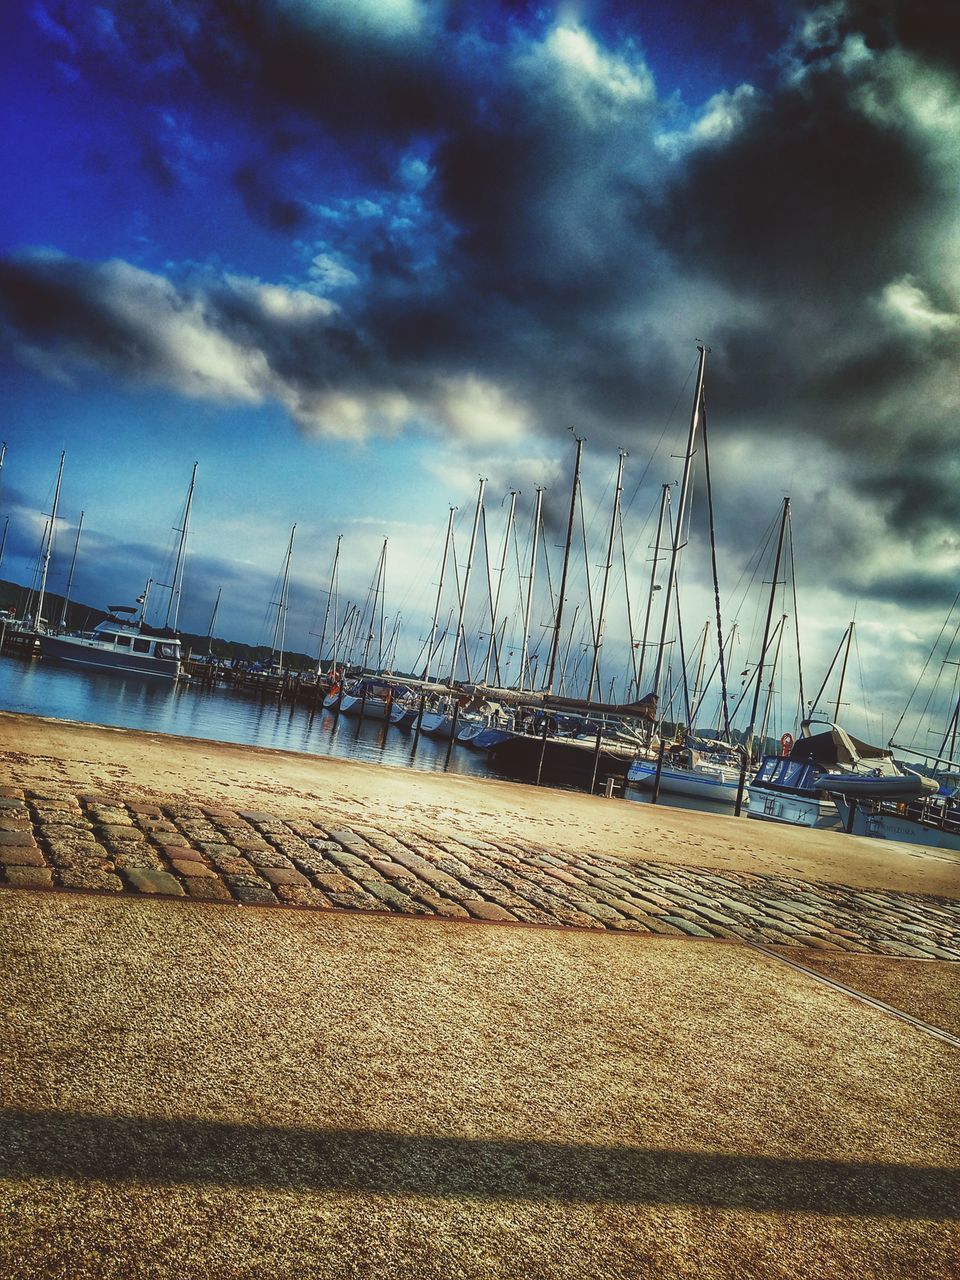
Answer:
[[0, 0, 960, 739]]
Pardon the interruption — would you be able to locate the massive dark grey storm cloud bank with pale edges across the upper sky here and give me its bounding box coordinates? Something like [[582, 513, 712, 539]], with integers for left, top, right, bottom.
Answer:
[[13, 0, 960, 570]]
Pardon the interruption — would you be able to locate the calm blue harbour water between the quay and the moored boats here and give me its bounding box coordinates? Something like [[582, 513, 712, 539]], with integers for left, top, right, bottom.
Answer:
[[0, 657, 730, 813]]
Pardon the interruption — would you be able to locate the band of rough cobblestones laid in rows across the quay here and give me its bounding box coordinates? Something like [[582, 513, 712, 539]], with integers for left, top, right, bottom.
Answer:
[[0, 787, 960, 960]]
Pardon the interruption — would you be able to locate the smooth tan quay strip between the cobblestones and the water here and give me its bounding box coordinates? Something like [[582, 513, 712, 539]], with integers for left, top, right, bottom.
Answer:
[[0, 713, 960, 897]]
